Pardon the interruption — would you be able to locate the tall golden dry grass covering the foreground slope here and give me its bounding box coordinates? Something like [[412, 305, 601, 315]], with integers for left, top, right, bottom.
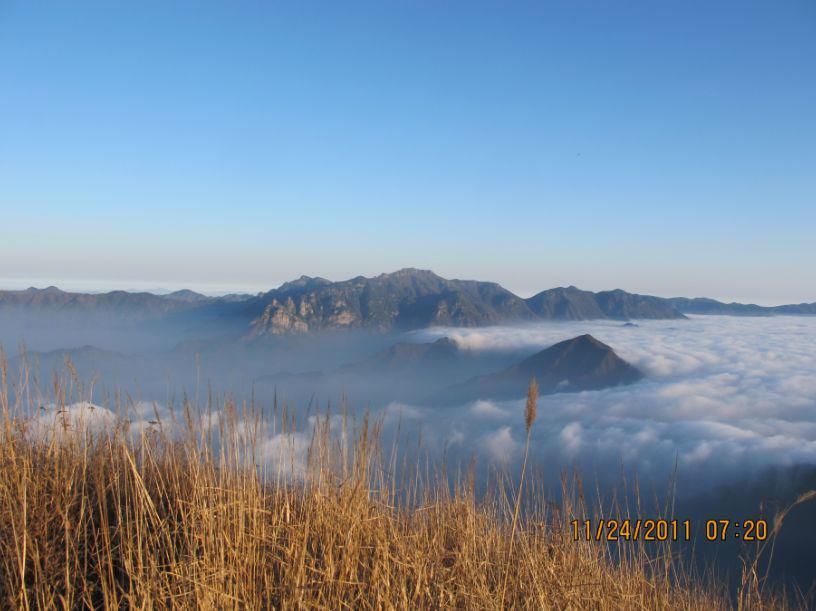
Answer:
[[0, 356, 800, 610]]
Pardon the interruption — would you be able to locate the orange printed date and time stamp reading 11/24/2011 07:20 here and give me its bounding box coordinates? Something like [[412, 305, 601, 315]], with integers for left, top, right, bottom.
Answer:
[[571, 518, 768, 541]]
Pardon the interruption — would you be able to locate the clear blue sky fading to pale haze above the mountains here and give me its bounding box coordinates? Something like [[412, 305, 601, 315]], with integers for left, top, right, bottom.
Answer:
[[0, 0, 816, 303]]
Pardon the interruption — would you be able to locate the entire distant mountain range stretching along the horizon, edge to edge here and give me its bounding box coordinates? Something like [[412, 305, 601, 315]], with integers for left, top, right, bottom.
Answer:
[[0, 269, 816, 339]]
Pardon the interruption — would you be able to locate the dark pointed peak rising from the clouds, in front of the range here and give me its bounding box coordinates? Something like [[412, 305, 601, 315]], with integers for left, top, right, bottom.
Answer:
[[442, 335, 643, 402]]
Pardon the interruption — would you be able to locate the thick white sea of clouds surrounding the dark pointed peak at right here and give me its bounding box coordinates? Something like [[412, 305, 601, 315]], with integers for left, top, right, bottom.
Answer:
[[398, 316, 816, 488]]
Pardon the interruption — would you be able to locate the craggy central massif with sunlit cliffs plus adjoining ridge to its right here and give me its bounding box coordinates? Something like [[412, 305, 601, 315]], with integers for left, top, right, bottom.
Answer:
[[250, 269, 684, 337]]
